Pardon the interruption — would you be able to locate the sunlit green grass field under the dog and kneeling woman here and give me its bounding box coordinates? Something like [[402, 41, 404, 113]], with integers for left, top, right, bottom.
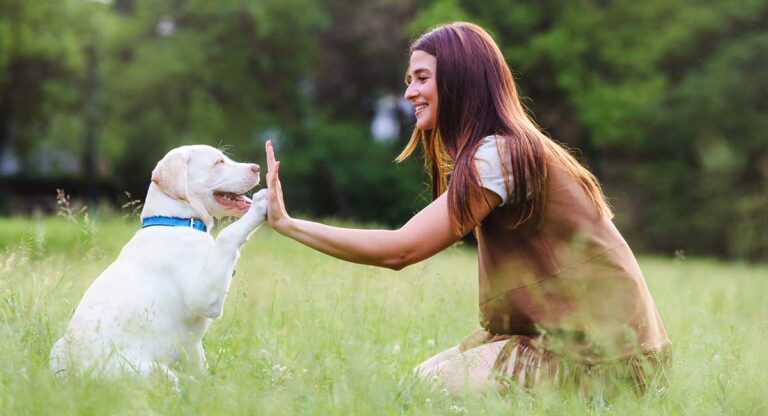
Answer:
[[0, 216, 768, 415]]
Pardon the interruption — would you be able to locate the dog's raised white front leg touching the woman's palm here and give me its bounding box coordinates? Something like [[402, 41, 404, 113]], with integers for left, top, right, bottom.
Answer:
[[187, 189, 267, 318]]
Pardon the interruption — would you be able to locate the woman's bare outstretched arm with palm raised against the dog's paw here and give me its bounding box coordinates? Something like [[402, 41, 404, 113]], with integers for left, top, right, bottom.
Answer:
[[266, 142, 501, 270]]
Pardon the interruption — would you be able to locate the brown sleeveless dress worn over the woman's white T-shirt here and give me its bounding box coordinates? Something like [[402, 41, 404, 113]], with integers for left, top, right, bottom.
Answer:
[[461, 160, 671, 394]]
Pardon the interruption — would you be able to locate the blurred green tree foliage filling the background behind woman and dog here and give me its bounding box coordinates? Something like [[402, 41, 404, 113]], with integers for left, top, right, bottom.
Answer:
[[0, 0, 768, 259]]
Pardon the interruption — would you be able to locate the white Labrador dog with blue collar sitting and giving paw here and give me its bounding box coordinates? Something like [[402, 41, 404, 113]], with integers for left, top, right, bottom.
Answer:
[[50, 145, 267, 385]]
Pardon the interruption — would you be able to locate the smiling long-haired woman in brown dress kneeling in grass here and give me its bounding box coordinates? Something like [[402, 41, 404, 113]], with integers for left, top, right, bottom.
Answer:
[[266, 23, 670, 393]]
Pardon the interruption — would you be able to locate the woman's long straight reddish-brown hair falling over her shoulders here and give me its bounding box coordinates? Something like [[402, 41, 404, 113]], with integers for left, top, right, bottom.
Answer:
[[396, 22, 613, 233]]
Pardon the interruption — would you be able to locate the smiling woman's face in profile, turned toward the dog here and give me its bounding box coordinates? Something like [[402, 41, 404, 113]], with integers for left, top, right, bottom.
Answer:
[[405, 51, 437, 130]]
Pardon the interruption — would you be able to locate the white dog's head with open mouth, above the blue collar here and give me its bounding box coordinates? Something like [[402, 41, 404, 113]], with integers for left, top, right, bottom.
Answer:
[[152, 145, 259, 225]]
